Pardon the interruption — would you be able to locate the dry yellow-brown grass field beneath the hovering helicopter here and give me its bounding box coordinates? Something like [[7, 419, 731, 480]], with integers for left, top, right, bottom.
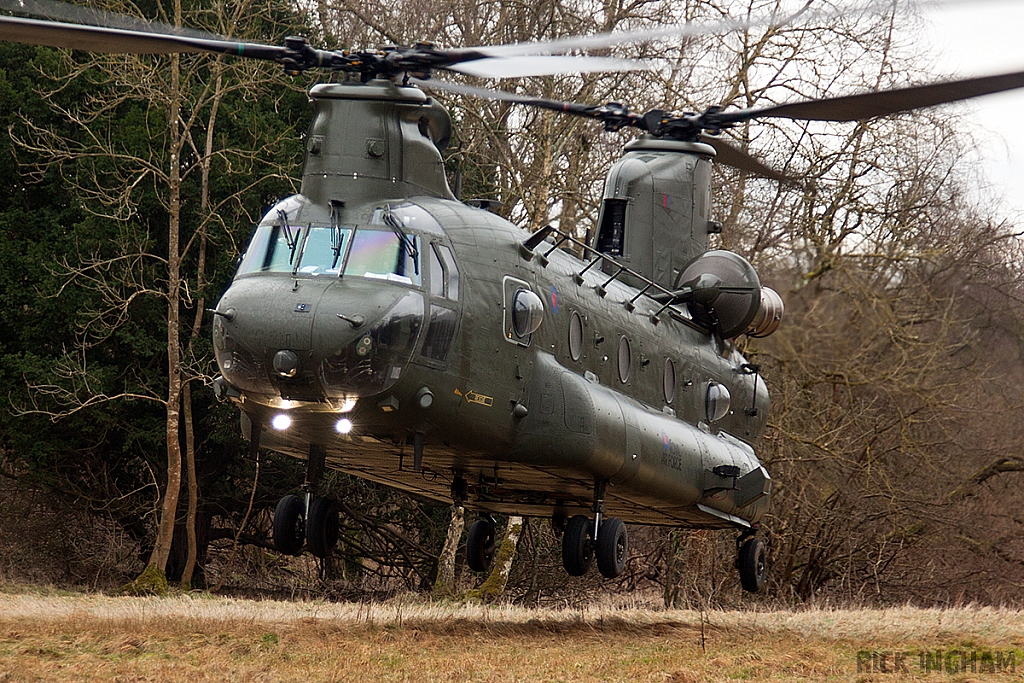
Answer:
[[0, 591, 1024, 683]]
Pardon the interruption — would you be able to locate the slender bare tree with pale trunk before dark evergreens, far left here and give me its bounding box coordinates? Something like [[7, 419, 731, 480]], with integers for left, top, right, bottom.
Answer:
[[18, 0, 303, 588]]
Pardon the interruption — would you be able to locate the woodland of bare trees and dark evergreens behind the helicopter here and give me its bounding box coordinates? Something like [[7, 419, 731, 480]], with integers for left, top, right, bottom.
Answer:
[[0, 0, 1024, 606]]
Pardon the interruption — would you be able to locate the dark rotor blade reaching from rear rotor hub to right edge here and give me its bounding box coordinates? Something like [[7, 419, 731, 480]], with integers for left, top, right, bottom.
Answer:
[[715, 72, 1024, 123]]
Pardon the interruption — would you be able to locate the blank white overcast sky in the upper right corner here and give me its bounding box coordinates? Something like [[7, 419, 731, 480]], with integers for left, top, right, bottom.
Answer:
[[924, 0, 1024, 215]]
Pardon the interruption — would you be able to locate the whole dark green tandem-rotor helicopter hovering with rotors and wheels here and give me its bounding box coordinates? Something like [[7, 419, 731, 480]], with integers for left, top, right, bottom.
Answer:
[[0, 0, 1024, 592]]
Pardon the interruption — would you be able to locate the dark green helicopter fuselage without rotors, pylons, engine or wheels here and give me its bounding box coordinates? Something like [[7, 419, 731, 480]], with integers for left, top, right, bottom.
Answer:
[[214, 196, 770, 527]]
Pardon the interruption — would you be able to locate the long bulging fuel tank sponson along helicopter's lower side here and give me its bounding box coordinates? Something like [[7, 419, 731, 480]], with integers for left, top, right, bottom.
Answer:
[[512, 353, 771, 522]]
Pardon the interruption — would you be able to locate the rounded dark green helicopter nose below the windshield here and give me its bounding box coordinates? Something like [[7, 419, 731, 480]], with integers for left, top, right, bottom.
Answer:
[[214, 278, 424, 401]]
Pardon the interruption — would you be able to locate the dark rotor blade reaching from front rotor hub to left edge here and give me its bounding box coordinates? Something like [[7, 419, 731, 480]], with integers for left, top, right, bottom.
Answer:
[[0, 15, 287, 60]]
